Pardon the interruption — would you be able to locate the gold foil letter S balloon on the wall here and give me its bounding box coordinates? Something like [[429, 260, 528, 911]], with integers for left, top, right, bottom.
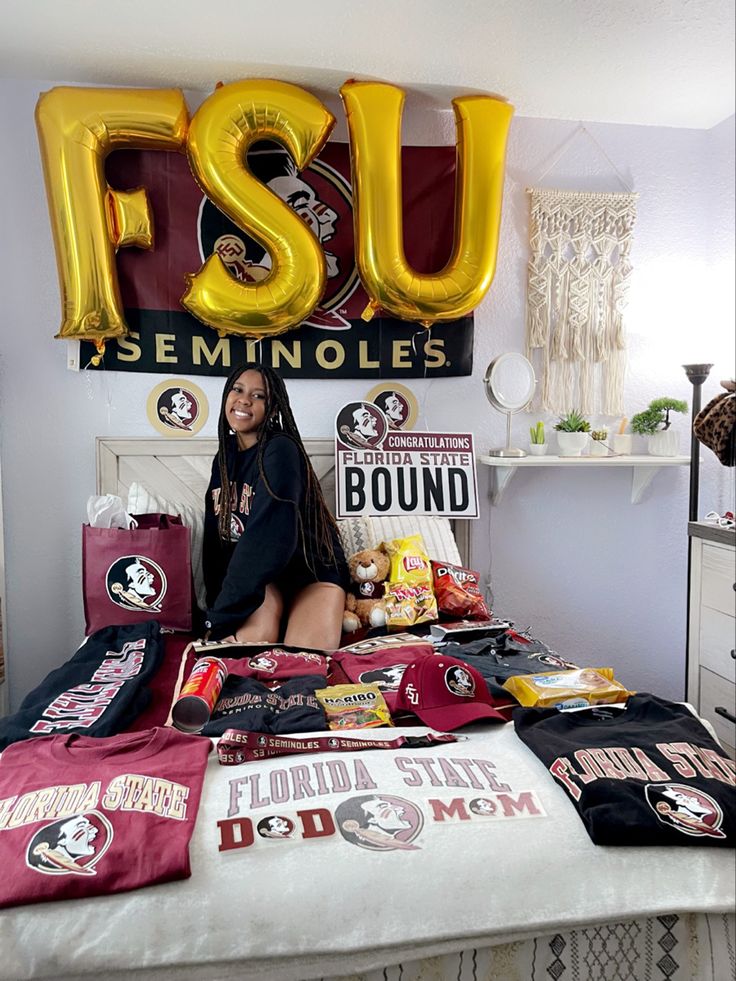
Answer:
[[181, 79, 335, 338]]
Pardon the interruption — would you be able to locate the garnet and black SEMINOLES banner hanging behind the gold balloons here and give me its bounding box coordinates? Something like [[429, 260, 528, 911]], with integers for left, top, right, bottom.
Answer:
[[81, 142, 473, 378]]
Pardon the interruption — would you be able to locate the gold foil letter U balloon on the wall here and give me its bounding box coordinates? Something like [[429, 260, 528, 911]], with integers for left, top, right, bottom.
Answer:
[[340, 82, 514, 326]]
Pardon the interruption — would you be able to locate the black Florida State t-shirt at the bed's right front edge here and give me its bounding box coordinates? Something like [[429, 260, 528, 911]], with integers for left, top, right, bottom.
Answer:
[[513, 694, 736, 847]]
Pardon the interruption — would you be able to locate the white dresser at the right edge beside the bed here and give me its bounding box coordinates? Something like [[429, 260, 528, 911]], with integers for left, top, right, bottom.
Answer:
[[687, 521, 736, 756]]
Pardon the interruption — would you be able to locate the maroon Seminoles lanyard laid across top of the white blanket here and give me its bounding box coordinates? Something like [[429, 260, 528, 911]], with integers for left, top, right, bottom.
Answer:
[[217, 729, 466, 766]]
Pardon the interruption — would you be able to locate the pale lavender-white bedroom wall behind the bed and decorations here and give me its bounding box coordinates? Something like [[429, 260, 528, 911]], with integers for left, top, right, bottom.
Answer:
[[0, 74, 734, 706]]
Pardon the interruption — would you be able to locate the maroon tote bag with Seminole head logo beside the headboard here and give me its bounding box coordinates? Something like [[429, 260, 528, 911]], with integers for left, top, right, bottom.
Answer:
[[82, 514, 192, 634]]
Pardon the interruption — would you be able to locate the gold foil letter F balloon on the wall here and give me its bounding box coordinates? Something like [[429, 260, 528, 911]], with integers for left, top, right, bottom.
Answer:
[[36, 87, 189, 353]]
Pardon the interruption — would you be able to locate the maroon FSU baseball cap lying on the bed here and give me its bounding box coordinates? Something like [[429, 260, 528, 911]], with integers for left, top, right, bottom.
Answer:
[[396, 654, 507, 731]]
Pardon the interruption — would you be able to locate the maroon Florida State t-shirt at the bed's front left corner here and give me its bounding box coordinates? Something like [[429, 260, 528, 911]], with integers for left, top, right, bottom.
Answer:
[[0, 729, 212, 908]]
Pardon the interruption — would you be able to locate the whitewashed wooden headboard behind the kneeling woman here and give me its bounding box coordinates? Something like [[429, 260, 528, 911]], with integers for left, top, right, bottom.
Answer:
[[96, 436, 471, 566]]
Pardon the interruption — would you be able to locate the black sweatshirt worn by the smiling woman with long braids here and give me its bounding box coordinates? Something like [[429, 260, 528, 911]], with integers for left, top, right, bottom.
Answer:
[[202, 433, 347, 640]]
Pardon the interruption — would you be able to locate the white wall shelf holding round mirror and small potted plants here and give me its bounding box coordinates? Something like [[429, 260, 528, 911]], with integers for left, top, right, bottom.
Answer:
[[478, 454, 690, 504]]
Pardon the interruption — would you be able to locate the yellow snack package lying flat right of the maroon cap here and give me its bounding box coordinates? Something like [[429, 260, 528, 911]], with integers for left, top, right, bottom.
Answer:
[[503, 668, 634, 710]]
